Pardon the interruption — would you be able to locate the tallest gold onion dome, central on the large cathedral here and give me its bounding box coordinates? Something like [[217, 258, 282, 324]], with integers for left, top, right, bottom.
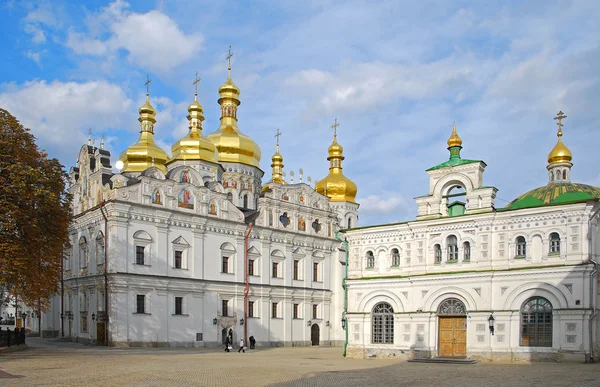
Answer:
[[206, 68, 261, 168]]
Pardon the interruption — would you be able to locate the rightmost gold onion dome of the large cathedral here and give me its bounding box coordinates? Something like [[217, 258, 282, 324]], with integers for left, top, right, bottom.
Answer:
[[315, 134, 358, 203]]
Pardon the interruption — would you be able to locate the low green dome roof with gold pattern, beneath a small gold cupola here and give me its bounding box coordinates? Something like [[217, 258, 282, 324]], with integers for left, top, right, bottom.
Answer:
[[504, 183, 600, 210]]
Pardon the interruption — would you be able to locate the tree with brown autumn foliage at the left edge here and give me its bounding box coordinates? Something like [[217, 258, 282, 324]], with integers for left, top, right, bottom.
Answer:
[[0, 109, 71, 310]]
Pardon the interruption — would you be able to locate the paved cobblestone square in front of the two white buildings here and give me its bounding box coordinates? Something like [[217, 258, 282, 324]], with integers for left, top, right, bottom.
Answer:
[[0, 338, 600, 387]]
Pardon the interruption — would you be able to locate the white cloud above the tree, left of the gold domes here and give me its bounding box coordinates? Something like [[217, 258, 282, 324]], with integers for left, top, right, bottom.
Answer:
[[0, 81, 135, 163]]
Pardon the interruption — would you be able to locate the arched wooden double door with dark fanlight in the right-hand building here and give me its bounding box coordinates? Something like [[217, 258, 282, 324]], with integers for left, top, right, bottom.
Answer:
[[437, 298, 467, 357]]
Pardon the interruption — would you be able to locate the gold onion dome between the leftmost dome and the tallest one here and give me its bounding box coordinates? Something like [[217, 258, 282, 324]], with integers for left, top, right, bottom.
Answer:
[[171, 93, 217, 163]]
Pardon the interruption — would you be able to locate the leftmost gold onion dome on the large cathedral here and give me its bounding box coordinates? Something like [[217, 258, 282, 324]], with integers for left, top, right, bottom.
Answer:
[[119, 93, 169, 173]]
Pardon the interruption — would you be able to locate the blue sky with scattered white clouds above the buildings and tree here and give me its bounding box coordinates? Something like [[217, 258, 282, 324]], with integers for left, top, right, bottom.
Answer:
[[0, 0, 600, 225]]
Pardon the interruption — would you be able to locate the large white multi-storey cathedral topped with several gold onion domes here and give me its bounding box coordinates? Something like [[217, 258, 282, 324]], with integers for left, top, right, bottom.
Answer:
[[44, 63, 359, 347]]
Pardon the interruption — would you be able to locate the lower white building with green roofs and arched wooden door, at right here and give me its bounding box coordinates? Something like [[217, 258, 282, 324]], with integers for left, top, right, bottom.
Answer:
[[341, 118, 600, 362]]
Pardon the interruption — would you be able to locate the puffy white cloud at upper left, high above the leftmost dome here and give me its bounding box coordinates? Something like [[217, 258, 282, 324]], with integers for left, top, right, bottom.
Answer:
[[66, 0, 203, 72]]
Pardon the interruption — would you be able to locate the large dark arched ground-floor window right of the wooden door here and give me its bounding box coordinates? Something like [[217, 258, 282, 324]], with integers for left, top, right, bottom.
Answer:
[[521, 297, 552, 347]]
